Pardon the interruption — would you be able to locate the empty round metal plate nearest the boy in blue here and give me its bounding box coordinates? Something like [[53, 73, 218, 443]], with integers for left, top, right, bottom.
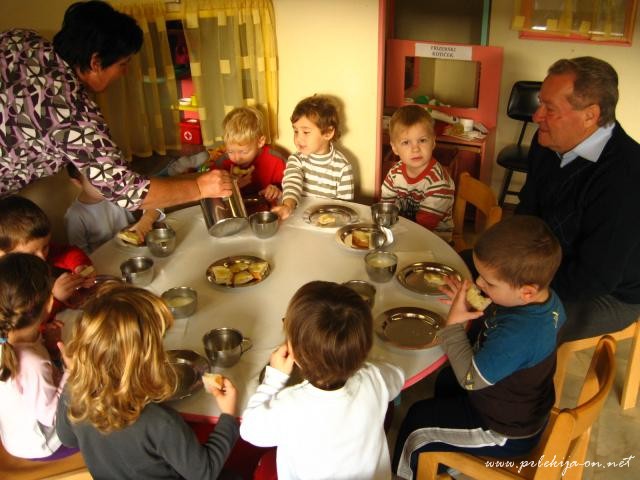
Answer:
[[375, 307, 444, 350]]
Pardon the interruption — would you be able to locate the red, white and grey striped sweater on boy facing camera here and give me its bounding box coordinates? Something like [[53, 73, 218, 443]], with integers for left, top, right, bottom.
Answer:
[[382, 157, 455, 241]]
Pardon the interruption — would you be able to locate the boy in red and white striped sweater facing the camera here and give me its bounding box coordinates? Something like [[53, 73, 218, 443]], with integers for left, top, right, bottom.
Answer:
[[381, 105, 455, 241]]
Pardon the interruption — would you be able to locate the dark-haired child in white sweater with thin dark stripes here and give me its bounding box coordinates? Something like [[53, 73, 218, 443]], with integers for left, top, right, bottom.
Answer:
[[272, 95, 353, 220]]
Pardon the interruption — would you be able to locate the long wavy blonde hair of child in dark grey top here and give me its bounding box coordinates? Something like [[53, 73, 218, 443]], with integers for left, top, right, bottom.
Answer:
[[67, 282, 177, 433]]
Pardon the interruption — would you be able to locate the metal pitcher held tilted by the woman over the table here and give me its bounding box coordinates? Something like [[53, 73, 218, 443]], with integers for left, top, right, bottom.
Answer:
[[200, 179, 247, 237]]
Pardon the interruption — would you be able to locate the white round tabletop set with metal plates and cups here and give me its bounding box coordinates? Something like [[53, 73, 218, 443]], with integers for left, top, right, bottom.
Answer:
[[70, 198, 469, 420]]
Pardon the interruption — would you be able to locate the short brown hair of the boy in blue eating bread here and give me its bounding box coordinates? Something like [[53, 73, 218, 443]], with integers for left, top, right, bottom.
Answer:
[[473, 215, 562, 289]]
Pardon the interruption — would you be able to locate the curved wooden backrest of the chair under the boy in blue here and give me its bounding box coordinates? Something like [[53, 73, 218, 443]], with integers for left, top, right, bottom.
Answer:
[[531, 335, 616, 478]]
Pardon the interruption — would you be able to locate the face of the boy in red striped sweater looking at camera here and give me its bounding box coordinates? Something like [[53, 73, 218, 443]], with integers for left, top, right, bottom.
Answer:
[[391, 123, 435, 177]]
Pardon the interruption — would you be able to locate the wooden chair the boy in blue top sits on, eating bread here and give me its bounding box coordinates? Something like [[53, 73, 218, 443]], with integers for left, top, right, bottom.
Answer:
[[417, 335, 616, 480]]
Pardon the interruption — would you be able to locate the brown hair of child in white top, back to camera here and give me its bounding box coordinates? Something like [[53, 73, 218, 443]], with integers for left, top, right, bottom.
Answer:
[[284, 281, 373, 390]]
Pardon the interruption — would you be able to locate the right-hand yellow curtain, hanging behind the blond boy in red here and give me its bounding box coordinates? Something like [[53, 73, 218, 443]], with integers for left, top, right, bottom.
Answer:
[[177, 0, 278, 146]]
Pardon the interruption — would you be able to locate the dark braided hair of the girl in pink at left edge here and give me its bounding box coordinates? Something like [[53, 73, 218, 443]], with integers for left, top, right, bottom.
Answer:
[[0, 253, 53, 382]]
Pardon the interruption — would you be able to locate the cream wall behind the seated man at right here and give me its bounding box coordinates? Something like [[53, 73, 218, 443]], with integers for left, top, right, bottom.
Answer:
[[489, 0, 640, 194]]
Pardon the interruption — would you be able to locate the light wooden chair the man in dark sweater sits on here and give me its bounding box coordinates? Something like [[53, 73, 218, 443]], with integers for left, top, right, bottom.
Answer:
[[554, 318, 640, 410]]
